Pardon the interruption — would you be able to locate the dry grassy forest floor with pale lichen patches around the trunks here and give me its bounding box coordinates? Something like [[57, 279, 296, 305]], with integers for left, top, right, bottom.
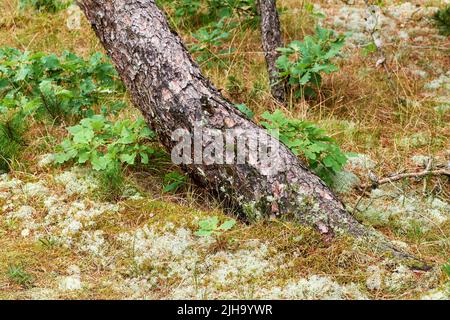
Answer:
[[0, 0, 450, 299]]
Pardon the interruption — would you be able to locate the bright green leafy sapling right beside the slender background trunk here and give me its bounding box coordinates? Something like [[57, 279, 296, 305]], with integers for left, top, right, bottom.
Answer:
[[276, 26, 345, 97]]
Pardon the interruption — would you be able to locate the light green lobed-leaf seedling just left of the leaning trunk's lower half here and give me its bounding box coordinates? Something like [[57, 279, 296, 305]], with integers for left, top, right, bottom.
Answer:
[[55, 115, 155, 171]]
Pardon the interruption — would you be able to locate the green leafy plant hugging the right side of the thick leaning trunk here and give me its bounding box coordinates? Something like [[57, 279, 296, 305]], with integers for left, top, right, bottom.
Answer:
[[261, 110, 347, 185]]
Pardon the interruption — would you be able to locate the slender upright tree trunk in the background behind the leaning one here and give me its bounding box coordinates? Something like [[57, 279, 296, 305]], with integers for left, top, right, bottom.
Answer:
[[257, 0, 286, 103]]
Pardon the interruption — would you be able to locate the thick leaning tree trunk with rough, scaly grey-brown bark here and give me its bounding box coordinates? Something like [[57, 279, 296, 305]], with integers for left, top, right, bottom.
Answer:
[[80, 0, 426, 264]]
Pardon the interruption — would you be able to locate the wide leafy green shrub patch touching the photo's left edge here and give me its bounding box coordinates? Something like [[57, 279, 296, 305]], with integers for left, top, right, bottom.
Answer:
[[0, 48, 124, 119]]
